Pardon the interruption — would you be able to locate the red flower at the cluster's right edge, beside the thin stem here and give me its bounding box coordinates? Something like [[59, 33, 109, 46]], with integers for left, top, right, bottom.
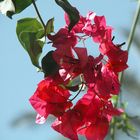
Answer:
[[99, 35, 128, 73]]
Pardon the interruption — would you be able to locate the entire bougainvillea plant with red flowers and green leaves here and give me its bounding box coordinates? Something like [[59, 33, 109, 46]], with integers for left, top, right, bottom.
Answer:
[[0, 0, 138, 140]]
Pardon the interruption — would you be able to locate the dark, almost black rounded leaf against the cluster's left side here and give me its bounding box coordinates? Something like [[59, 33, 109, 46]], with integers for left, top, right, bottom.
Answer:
[[41, 51, 59, 77]]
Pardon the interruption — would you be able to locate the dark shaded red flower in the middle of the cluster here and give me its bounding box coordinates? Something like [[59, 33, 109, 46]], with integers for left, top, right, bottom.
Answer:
[[53, 47, 88, 79]]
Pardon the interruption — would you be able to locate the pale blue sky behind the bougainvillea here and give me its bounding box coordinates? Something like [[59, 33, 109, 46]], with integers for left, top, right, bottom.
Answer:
[[0, 0, 140, 140]]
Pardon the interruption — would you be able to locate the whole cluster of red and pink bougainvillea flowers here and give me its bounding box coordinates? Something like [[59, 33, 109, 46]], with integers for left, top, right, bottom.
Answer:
[[30, 12, 128, 140]]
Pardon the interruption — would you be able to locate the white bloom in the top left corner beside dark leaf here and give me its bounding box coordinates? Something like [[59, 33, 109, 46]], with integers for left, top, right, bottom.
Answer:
[[0, 0, 15, 15]]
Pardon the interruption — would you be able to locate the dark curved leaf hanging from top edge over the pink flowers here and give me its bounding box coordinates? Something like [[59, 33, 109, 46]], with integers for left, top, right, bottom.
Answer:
[[55, 0, 80, 31]]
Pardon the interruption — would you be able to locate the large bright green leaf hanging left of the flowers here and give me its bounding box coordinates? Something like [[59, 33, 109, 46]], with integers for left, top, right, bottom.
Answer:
[[16, 18, 44, 68]]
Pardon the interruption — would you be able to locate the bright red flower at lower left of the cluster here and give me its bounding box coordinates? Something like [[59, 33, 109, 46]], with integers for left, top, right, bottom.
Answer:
[[30, 78, 71, 122]]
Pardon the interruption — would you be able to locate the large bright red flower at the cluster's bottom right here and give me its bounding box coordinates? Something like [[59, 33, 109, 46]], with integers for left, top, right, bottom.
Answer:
[[74, 89, 123, 140]]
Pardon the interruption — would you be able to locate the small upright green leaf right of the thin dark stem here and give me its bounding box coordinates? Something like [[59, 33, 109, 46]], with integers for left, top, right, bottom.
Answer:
[[45, 18, 54, 35]]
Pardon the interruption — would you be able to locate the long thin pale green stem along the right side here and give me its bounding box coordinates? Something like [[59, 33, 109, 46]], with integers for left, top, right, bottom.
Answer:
[[111, 0, 140, 140]]
